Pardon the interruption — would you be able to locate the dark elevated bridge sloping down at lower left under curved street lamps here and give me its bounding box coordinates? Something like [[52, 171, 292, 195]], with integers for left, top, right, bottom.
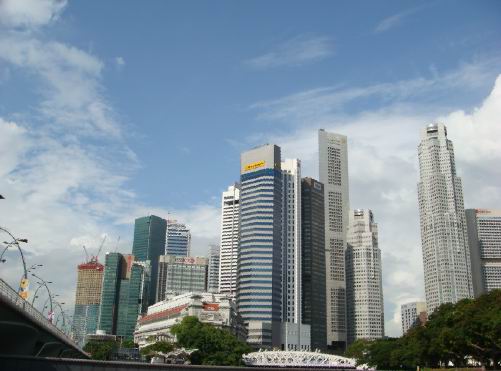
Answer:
[[0, 279, 89, 359]]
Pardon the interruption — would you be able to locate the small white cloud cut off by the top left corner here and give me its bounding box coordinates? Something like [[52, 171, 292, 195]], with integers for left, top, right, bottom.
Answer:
[[0, 0, 67, 28]]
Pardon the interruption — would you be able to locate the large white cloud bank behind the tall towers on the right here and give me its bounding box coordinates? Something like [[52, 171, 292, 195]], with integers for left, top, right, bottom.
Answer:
[[249, 62, 501, 335]]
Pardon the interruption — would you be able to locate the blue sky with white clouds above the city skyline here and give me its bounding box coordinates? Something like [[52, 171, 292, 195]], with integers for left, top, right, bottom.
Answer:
[[0, 0, 501, 336]]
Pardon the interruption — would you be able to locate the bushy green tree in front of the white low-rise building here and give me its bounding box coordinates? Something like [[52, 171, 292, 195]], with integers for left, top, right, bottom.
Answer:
[[171, 316, 251, 366]]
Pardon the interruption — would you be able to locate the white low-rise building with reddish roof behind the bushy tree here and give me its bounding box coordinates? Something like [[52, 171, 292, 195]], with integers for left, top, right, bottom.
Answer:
[[134, 292, 247, 348]]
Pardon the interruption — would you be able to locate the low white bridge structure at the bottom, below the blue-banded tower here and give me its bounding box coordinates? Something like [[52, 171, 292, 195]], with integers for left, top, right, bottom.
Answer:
[[242, 350, 357, 369]]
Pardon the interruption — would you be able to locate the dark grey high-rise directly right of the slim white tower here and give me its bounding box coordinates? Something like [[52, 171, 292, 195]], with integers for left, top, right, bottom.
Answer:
[[301, 178, 327, 350]]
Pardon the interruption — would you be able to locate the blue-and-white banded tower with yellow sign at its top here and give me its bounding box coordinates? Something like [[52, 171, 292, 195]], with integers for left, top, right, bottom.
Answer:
[[237, 144, 282, 347]]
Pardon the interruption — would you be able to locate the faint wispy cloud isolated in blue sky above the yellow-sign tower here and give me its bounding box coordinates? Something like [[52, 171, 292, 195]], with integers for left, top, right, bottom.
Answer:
[[246, 35, 334, 69]]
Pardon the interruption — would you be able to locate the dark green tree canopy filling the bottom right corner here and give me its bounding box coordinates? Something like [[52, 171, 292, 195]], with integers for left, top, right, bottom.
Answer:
[[346, 290, 501, 369]]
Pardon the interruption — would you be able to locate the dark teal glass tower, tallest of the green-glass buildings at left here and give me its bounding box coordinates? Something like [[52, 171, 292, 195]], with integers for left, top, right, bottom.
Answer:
[[132, 215, 167, 305]]
